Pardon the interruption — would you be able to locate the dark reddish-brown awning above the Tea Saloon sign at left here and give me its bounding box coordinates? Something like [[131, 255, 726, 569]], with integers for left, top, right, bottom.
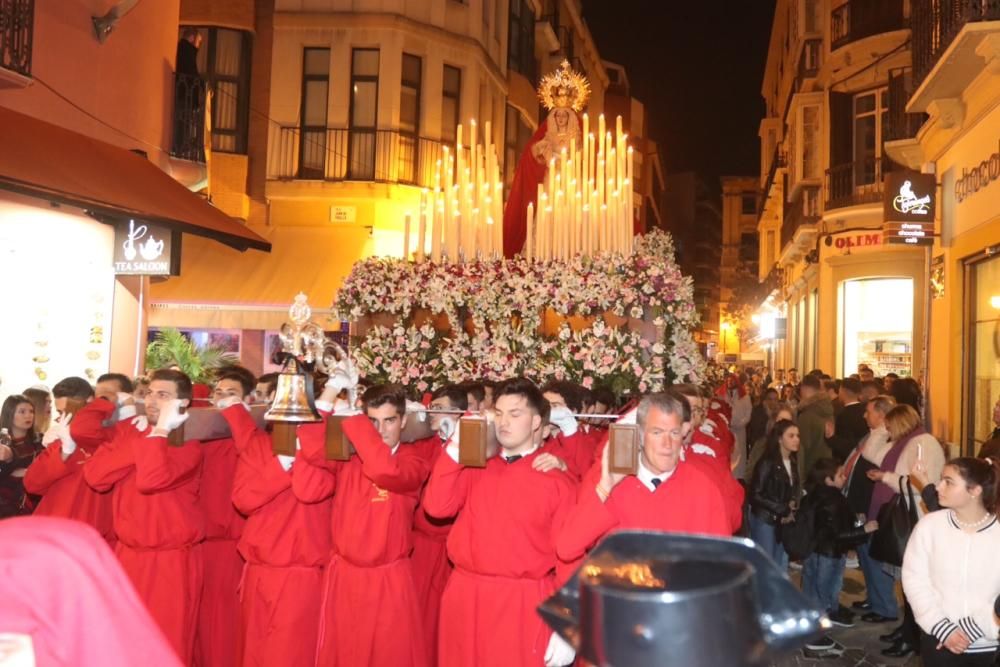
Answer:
[[0, 107, 271, 251]]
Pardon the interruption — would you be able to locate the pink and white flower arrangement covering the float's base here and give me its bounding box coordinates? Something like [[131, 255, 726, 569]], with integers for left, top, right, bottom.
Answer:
[[334, 230, 706, 394]]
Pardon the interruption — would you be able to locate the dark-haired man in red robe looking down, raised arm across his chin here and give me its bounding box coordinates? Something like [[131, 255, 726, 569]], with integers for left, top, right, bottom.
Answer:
[[292, 385, 429, 667]]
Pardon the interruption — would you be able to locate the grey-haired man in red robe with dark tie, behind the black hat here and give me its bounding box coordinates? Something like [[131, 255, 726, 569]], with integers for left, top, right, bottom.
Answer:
[[557, 392, 732, 562]]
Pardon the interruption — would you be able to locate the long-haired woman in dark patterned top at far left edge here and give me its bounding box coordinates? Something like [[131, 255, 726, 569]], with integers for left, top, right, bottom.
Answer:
[[0, 394, 42, 519]]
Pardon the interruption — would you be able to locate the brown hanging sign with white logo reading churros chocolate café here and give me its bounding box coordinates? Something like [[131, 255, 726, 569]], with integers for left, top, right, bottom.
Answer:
[[882, 170, 937, 245]]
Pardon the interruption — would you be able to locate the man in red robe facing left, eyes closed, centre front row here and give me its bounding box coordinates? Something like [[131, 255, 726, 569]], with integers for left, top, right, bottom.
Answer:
[[424, 378, 576, 667]]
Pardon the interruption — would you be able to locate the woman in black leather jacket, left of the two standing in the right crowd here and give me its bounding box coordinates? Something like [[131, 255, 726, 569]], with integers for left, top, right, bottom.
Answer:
[[750, 419, 802, 567]]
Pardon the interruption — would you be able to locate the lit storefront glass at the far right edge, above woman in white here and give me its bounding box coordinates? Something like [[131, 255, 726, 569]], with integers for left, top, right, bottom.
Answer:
[[965, 254, 1000, 454]]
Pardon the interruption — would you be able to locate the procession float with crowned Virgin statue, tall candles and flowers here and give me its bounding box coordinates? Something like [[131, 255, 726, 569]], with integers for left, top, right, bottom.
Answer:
[[334, 61, 706, 395]]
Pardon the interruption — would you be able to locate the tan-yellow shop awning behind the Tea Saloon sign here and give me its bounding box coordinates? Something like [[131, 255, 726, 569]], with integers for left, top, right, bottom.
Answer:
[[149, 226, 372, 329]]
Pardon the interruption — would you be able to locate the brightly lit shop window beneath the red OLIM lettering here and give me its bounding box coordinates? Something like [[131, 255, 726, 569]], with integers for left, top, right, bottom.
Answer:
[[840, 278, 913, 377]]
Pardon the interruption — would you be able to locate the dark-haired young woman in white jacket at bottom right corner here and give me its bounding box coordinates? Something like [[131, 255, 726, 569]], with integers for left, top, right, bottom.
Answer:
[[903, 458, 1000, 667]]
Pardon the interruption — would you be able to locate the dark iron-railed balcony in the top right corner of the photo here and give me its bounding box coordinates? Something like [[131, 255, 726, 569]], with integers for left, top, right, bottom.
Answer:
[[910, 0, 1000, 88]]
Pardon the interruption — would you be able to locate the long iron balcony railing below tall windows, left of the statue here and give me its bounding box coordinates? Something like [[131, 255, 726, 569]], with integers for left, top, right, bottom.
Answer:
[[267, 127, 448, 187]]
